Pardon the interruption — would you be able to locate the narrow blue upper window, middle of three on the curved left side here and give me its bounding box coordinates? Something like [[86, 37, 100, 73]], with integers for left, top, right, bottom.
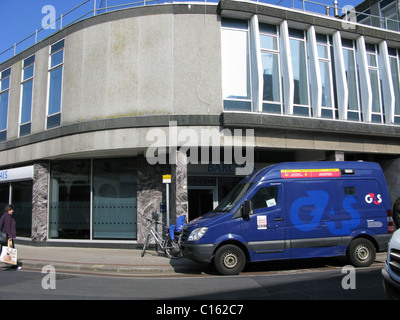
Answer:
[[19, 56, 35, 136]]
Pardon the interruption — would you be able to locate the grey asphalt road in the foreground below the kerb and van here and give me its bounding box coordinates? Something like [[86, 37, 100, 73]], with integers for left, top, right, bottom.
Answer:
[[0, 264, 386, 302]]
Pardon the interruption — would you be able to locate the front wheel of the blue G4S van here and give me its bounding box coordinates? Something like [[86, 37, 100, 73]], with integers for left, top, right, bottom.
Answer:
[[214, 244, 246, 275]]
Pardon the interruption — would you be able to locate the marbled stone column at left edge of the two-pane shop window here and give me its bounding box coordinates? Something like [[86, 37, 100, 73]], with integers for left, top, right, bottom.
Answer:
[[32, 162, 49, 242]]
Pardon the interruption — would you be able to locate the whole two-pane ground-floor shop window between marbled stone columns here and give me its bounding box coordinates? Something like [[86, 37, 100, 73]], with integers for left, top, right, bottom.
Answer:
[[49, 158, 137, 240]]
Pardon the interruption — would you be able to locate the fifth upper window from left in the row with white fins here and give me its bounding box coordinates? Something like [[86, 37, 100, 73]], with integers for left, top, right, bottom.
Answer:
[[342, 39, 361, 121]]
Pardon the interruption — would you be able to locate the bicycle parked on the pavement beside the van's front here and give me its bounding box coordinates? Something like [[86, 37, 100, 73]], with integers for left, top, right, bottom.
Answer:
[[142, 218, 182, 259]]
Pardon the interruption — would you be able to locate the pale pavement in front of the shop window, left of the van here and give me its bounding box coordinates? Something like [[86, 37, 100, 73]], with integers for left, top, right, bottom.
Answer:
[[0, 244, 207, 276]]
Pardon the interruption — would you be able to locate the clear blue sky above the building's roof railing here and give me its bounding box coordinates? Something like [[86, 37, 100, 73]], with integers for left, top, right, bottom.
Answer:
[[0, 0, 362, 62]]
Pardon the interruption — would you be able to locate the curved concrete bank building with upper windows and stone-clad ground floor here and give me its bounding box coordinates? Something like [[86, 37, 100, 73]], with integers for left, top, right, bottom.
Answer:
[[0, 0, 400, 246]]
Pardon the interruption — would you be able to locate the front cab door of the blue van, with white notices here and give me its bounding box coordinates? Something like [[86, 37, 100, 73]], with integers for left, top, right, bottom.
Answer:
[[241, 182, 286, 261]]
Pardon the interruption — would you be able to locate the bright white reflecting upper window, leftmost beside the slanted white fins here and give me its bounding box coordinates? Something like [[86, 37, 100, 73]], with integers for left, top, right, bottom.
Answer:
[[221, 19, 251, 111]]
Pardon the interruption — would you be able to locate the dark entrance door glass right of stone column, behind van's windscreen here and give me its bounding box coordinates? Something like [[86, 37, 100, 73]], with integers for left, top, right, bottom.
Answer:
[[188, 187, 218, 221]]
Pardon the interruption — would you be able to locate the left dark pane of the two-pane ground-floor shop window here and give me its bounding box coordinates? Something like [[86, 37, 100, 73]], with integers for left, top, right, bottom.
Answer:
[[49, 160, 90, 239]]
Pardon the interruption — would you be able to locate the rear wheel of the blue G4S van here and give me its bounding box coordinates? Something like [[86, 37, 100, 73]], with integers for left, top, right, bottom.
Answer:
[[347, 238, 376, 267]]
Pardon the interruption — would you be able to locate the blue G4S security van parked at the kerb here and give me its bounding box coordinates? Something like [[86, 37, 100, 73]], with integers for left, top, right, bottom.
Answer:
[[181, 161, 394, 275]]
